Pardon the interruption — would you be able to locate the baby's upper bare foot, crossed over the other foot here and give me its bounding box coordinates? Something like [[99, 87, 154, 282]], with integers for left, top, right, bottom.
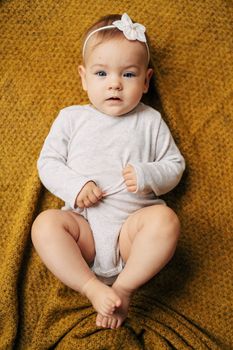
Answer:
[[82, 277, 121, 316]]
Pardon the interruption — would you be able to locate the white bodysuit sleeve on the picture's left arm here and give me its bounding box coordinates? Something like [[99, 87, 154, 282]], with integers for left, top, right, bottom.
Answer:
[[37, 110, 91, 208]]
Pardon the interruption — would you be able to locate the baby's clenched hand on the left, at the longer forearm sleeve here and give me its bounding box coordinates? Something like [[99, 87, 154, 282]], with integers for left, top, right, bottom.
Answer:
[[75, 181, 104, 208]]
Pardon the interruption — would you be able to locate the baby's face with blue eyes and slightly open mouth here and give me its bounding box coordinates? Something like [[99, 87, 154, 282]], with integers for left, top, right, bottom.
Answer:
[[79, 37, 153, 116]]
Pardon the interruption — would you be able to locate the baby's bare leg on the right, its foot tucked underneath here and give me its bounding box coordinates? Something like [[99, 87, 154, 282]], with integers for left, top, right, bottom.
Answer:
[[97, 205, 180, 328]]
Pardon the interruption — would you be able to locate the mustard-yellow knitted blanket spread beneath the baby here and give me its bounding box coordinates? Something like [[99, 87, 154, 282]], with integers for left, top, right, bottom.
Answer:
[[0, 0, 233, 350]]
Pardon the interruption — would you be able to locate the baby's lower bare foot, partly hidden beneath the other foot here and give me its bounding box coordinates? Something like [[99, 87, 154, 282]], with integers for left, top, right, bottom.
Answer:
[[96, 282, 132, 329]]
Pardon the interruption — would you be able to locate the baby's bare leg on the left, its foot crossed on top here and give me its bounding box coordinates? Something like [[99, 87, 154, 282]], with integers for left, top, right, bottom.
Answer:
[[32, 209, 121, 315]]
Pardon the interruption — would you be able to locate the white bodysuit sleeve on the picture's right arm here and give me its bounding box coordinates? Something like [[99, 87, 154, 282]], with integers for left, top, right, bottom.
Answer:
[[132, 119, 185, 196]]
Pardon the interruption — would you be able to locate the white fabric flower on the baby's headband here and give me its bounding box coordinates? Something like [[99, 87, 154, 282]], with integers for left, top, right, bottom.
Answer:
[[112, 13, 146, 43]]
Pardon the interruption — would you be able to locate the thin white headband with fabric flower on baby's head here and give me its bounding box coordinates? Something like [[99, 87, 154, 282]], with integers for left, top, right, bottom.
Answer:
[[83, 13, 150, 62]]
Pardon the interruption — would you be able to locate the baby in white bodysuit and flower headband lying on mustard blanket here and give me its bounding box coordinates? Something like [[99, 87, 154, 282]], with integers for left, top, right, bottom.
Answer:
[[32, 14, 185, 328]]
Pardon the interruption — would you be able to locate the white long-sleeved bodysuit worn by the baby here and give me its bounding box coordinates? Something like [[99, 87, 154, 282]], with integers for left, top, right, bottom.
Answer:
[[38, 103, 185, 278]]
